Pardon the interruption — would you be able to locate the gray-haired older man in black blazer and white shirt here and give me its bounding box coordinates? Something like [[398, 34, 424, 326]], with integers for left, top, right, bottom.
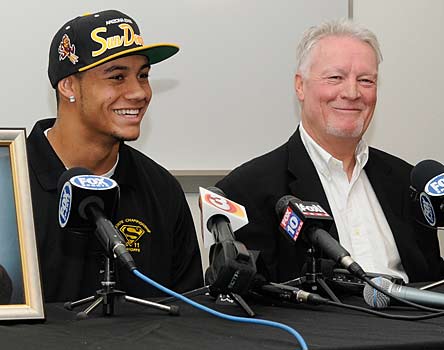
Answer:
[[217, 21, 444, 282]]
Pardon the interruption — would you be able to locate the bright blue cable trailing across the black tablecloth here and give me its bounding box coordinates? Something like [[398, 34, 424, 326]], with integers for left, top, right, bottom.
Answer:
[[133, 269, 308, 350]]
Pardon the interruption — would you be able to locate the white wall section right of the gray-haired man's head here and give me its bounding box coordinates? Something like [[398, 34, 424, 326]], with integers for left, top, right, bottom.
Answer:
[[353, 0, 444, 255]]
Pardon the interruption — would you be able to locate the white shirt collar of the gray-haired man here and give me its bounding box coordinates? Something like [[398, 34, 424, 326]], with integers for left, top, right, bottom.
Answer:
[[299, 122, 368, 179]]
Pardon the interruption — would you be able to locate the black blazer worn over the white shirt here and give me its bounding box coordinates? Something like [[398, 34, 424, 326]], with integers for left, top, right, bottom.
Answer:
[[216, 130, 444, 282]]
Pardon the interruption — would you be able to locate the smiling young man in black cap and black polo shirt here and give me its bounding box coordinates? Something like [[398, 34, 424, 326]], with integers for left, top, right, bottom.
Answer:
[[28, 10, 203, 301]]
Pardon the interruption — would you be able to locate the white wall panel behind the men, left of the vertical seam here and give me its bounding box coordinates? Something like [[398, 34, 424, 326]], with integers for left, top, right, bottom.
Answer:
[[0, 0, 348, 170]]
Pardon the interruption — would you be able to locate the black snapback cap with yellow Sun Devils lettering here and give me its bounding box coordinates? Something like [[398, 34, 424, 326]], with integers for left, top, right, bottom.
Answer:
[[48, 10, 179, 88]]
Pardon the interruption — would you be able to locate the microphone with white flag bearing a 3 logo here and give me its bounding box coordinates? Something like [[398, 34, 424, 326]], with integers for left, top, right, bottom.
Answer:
[[200, 187, 256, 295]]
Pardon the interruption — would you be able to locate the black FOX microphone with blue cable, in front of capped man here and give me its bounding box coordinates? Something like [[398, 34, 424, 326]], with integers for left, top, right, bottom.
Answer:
[[57, 168, 136, 271]]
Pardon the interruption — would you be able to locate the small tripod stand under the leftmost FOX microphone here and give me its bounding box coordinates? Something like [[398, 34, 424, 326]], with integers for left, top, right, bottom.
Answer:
[[64, 255, 179, 320]]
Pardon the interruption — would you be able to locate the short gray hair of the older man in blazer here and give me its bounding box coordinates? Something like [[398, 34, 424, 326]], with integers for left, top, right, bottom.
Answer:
[[297, 19, 382, 76]]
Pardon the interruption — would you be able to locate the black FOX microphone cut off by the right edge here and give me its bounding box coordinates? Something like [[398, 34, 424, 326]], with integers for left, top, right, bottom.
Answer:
[[410, 159, 444, 227]]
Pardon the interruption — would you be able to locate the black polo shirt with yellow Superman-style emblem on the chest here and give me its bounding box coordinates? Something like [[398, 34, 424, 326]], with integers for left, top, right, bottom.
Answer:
[[27, 119, 203, 301]]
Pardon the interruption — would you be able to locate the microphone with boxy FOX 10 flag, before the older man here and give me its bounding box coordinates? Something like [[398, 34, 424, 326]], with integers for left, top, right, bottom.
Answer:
[[275, 195, 366, 278]]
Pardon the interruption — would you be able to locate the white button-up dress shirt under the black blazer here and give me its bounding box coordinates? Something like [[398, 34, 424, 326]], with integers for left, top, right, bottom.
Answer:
[[299, 123, 408, 282]]
